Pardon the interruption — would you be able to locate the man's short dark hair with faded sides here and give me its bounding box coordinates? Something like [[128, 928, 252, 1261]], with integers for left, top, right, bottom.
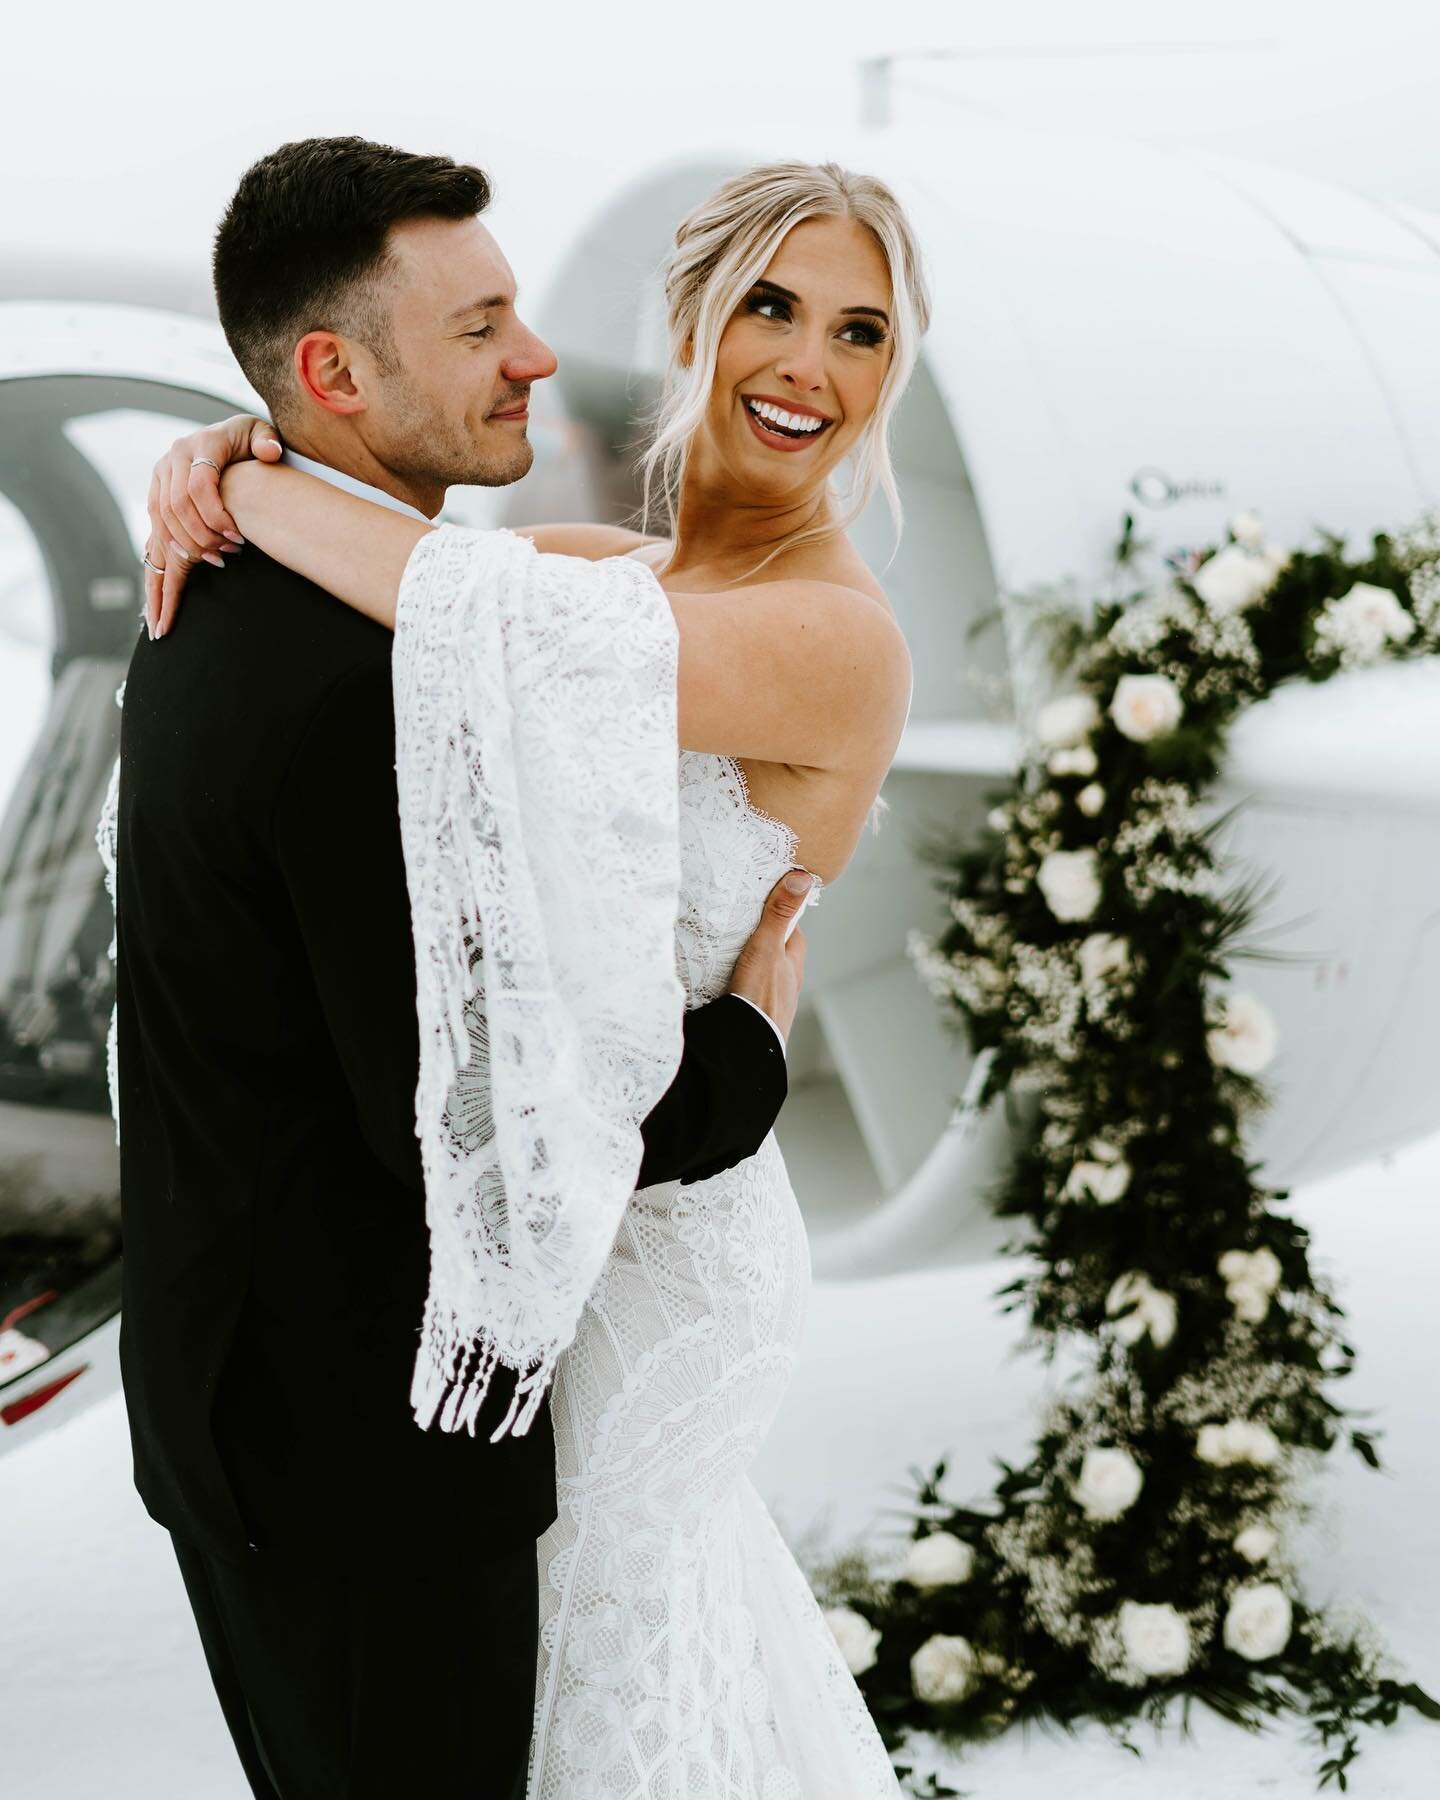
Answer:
[[212, 137, 490, 427]]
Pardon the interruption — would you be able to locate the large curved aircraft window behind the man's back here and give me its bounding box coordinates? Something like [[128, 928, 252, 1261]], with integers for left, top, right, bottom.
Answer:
[[0, 387, 214, 1391]]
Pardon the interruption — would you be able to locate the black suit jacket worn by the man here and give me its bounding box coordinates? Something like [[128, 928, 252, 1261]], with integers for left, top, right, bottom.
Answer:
[[117, 544, 785, 1566]]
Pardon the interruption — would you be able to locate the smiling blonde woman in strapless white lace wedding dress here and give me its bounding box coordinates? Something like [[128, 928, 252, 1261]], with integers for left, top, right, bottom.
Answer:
[[148, 164, 929, 1800]]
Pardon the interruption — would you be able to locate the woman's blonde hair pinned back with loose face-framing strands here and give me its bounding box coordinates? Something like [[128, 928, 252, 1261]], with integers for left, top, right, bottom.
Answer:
[[641, 162, 931, 574]]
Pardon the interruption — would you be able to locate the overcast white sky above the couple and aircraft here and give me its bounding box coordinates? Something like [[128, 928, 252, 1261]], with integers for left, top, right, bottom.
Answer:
[[0, 0, 1440, 309]]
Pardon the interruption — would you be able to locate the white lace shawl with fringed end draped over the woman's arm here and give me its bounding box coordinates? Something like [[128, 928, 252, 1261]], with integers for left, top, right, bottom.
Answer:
[[99, 526, 684, 1442]]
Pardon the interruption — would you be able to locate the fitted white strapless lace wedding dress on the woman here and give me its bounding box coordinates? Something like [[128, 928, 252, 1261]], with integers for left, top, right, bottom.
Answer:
[[527, 751, 900, 1800]]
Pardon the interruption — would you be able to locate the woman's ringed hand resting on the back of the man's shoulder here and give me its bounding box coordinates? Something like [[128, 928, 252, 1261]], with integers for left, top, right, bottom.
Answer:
[[144, 412, 283, 637]]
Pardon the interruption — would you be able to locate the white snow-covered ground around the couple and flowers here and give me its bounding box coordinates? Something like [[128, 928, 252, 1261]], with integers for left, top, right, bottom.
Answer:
[[0, 1139, 1440, 1800]]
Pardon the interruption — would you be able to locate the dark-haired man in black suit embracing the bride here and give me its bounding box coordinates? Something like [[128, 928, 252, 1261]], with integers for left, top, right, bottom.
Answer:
[[117, 139, 808, 1800]]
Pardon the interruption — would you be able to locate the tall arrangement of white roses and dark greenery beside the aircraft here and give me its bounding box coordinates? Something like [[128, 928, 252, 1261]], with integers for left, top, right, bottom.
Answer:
[[812, 513, 1440, 1795]]
